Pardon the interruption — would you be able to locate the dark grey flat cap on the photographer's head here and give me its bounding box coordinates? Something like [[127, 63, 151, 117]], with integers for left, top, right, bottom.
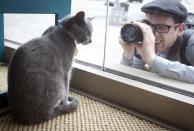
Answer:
[[141, 0, 188, 22]]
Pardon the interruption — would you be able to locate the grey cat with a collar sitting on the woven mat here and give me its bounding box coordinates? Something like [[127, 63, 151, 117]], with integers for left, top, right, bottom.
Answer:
[[8, 11, 92, 124]]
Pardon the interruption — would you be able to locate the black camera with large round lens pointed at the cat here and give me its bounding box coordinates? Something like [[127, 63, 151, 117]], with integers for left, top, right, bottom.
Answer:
[[120, 19, 151, 43]]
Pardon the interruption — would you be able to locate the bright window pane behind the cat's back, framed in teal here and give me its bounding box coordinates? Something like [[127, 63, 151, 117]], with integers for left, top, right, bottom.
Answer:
[[4, 13, 55, 44]]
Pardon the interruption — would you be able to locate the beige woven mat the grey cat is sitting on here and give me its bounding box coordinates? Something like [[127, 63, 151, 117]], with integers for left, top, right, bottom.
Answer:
[[0, 66, 170, 131]]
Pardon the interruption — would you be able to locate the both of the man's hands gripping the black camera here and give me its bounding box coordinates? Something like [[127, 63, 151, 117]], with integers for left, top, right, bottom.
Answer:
[[119, 22, 156, 67]]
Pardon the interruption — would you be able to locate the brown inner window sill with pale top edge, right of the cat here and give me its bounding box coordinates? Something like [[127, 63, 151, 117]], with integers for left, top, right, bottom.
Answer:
[[71, 63, 194, 130]]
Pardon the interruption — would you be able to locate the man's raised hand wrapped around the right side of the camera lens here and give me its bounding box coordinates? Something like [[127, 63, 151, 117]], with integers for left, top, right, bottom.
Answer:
[[135, 22, 156, 67]]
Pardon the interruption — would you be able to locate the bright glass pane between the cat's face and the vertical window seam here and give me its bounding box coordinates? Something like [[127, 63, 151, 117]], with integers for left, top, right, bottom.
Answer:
[[71, 0, 107, 66]]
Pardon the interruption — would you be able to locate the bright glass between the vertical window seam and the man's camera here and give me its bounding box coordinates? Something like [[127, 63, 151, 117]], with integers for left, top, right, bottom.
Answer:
[[106, 0, 145, 66]]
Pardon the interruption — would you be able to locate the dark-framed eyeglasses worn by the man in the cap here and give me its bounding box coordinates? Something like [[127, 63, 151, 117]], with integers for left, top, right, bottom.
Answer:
[[150, 24, 180, 33]]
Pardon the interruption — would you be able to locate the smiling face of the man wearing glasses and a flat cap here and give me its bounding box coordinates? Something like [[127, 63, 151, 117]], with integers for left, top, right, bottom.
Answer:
[[147, 13, 181, 53]]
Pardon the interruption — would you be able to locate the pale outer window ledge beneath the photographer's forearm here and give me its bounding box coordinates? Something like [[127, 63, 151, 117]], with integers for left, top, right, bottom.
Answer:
[[106, 63, 194, 97]]
